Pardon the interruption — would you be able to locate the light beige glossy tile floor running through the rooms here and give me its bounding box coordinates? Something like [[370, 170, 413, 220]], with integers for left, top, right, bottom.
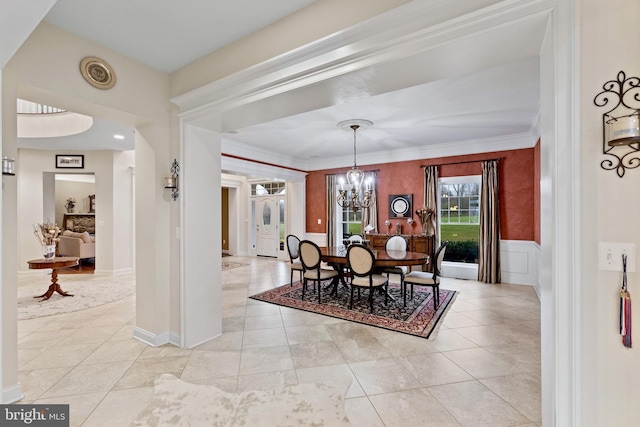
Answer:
[[18, 257, 541, 427]]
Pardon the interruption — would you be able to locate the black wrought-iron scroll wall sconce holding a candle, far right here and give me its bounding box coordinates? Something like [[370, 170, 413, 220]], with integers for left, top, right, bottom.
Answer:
[[593, 71, 640, 178]]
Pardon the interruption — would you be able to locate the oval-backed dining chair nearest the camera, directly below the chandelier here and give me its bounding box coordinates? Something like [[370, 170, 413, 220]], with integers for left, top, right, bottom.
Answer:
[[347, 245, 389, 313]]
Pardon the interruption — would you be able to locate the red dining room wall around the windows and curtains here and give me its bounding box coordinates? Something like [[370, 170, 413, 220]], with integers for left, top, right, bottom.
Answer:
[[306, 146, 540, 242]]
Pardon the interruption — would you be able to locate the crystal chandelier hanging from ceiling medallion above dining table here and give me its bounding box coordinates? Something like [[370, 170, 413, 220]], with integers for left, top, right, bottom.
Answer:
[[338, 119, 373, 212]]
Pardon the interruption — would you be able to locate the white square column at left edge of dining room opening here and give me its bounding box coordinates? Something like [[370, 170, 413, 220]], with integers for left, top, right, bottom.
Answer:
[[179, 125, 222, 348]]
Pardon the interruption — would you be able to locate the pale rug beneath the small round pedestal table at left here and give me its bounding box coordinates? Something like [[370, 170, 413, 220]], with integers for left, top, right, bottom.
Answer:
[[18, 274, 136, 320]]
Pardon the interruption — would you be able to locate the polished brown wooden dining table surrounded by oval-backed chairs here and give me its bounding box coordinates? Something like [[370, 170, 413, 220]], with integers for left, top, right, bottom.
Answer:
[[320, 246, 429, 299]]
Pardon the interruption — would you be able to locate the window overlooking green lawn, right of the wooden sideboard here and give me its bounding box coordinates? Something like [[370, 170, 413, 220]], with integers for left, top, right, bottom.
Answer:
[[439, 175, 481, 264]]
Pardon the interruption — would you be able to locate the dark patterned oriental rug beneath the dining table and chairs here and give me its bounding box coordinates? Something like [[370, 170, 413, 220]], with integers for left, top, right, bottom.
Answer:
[[250, 282, 456, 339]]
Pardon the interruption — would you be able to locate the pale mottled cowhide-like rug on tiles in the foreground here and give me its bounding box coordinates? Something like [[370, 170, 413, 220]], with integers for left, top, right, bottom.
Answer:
[[133, 374, 351, 427]]
